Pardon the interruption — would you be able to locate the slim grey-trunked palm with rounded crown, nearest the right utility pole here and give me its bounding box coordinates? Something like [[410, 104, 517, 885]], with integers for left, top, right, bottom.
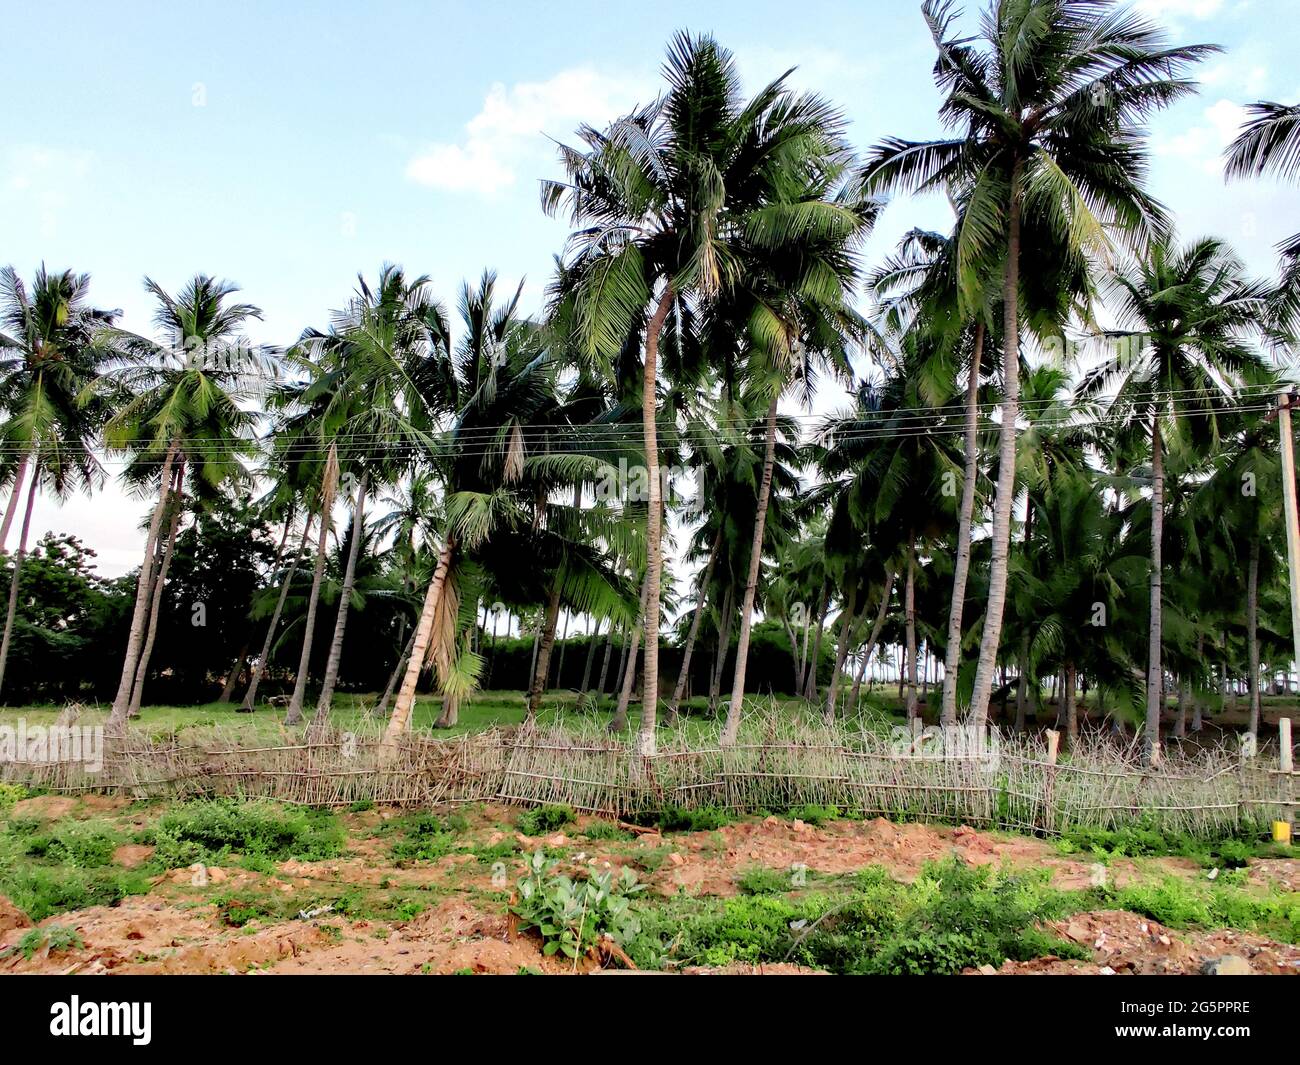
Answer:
[[1079, 238, 1269, 761]]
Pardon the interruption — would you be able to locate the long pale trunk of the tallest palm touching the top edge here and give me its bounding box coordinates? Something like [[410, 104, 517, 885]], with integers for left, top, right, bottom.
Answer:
[[970, 169, 1021, 728]]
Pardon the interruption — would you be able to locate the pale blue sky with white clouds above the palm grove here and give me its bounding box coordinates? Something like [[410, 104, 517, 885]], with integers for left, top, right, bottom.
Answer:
[[0, 0, 1300, 573]]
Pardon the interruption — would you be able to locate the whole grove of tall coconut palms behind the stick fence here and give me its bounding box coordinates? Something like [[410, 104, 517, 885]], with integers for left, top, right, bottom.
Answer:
[[0, 0, 1300, 758]]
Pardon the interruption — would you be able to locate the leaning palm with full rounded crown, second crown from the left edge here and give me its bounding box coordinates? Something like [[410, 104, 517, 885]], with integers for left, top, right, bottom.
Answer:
[[96, 274, 266, 731]]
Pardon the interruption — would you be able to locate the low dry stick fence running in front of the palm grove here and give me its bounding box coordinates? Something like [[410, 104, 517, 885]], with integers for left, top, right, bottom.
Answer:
[[0, 723, 1297, 836]]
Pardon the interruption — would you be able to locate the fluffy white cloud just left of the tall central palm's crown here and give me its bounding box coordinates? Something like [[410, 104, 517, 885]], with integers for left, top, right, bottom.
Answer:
[[406, 66, 654, 196]]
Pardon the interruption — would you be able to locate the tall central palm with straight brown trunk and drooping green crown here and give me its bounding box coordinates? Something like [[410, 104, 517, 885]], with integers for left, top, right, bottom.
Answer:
[[542, 34, 868, 752]]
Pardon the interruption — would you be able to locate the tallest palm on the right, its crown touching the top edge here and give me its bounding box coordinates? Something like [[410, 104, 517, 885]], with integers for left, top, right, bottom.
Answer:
[[863, 0, 1217, 724]]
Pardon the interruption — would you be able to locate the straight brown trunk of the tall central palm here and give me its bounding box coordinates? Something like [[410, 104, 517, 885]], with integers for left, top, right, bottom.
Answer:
[[637, 285, 673, 754]]
